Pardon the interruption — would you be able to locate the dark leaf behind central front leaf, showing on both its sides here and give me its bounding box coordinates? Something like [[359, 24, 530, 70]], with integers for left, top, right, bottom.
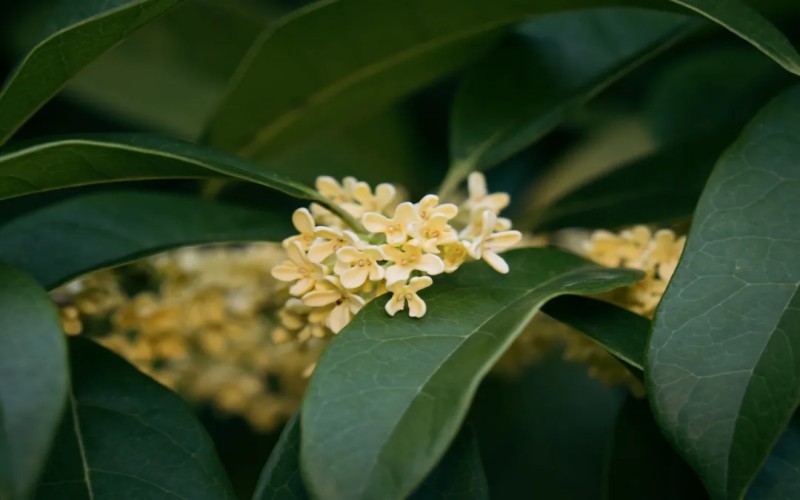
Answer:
[[253, 414, 489, 500]]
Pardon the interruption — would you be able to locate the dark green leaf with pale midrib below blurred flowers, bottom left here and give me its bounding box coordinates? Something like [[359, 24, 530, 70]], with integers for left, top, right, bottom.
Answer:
[[36, 338, 235, 500]]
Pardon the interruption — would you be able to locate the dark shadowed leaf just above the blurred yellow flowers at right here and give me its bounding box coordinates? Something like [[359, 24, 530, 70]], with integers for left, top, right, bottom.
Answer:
[[530, 134, 730, 231]]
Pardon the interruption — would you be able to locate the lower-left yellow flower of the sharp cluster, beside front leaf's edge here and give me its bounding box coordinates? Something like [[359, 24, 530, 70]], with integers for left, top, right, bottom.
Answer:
[[303, 276, 366, 333]]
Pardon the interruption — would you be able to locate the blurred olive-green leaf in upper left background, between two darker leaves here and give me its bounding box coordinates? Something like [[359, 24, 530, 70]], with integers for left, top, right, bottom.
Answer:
[[64, 0, 266, 139]]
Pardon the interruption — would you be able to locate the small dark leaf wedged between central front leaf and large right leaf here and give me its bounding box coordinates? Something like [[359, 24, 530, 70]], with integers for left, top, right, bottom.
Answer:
[[542, 296, 650, 371]]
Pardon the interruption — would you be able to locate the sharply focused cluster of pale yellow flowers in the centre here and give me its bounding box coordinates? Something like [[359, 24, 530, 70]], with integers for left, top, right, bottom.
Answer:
[[272, 173, 522, 333]]
